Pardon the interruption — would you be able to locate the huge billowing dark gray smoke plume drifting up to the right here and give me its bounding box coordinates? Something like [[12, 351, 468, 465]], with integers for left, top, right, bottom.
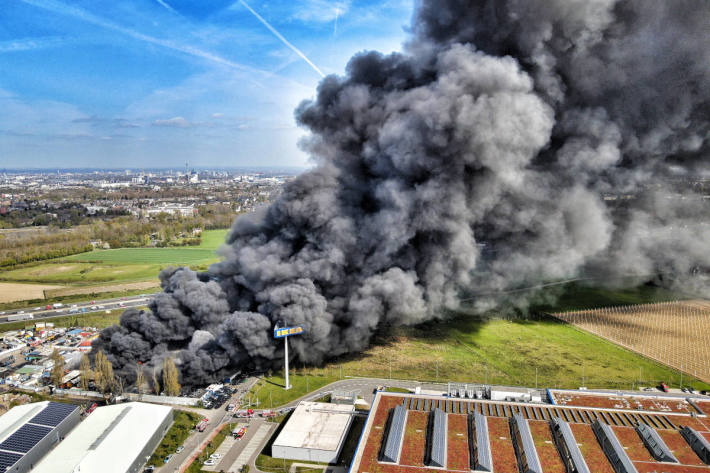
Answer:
[[95, 0, 710, 385]]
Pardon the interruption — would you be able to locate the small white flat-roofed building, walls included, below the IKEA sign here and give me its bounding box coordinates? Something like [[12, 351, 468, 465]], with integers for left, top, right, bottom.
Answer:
[[271, 401, 355, 463]]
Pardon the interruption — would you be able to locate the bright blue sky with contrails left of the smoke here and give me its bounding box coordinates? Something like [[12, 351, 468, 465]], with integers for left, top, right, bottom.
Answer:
[[0, 0, 413, 168]]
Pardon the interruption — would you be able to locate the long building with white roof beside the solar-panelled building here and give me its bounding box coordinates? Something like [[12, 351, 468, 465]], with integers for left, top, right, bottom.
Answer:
[[32, 402, 173, 473]]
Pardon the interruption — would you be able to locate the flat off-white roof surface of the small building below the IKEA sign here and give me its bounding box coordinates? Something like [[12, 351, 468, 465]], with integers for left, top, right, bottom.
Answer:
[[274, 401, 355, 452]]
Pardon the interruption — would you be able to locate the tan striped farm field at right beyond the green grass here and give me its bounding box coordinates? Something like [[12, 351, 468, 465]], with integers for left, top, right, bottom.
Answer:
[[550, 301, 710, 382]]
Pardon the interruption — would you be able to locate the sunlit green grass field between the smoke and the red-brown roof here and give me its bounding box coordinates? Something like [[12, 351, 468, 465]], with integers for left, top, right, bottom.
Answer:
[[251, 315, 710, 408]]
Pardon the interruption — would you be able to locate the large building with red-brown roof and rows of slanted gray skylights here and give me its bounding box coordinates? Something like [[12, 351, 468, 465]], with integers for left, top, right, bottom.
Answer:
[[350, 386, 710, 473]]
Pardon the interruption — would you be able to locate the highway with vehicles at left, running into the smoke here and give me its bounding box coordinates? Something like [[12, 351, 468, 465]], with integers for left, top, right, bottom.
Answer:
[[0, 294, 153, 327]]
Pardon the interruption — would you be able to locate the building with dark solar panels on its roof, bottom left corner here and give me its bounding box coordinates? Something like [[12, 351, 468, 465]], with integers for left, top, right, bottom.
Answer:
[[0, 401, 79, 473]]
